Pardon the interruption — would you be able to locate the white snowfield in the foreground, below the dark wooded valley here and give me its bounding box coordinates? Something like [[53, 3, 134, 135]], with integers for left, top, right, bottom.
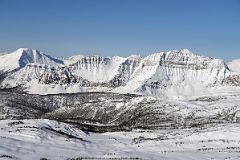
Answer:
[[0, 119, 240, 160]]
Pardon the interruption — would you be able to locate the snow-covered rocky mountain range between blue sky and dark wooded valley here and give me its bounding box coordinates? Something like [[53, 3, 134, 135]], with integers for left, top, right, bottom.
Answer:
[[0, 48, 240, 97]]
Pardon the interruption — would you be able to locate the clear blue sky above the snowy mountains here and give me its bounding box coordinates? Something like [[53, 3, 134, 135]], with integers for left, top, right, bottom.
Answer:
[[0, 0, 240, 61]]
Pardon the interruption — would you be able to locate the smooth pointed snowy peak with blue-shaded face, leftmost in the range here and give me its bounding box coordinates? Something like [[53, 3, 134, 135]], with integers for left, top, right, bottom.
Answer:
[[0, 48, 63, 72]]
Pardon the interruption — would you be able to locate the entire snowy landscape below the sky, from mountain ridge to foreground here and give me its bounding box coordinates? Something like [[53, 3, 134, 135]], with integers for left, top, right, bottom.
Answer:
[[0, 48, 240, 160]]
